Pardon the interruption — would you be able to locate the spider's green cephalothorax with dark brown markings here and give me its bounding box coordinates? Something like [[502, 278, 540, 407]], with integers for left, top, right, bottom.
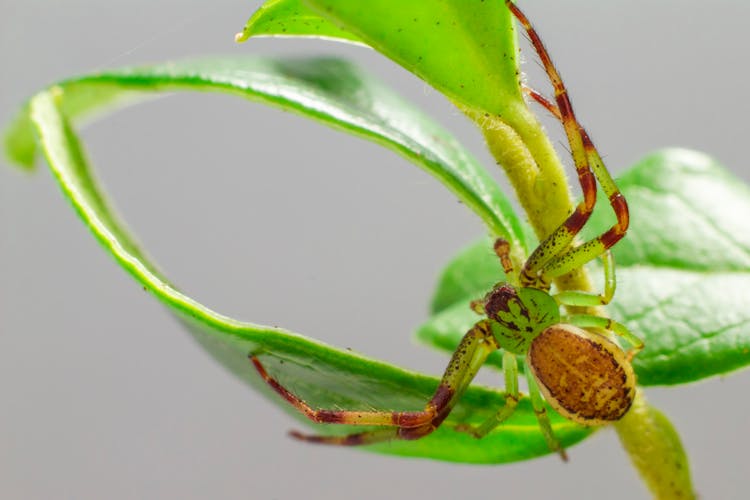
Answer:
[[482, 284, 560, 355]]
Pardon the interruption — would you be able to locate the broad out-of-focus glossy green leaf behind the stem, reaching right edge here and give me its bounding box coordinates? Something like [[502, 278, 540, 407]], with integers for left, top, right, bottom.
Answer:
[[417, 149, 750, 385]]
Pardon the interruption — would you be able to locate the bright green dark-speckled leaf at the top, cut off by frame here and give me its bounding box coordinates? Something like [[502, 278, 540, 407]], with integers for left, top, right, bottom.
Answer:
[[237, 0, 525, 116]]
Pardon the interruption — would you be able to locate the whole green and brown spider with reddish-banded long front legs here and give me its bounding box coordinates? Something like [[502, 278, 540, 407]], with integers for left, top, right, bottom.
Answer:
[[250, 0, 643, 460]]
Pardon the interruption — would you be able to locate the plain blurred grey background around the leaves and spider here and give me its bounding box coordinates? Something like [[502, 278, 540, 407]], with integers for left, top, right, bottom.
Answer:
[[0, 0, 750, 499]]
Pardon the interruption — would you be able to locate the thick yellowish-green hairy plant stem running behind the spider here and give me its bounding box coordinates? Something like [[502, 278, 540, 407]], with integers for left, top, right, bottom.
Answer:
[[464, 104, 695, 500]]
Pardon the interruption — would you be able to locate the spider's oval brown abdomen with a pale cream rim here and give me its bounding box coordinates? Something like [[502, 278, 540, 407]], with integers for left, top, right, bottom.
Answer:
[[526, 324, 635, 425]]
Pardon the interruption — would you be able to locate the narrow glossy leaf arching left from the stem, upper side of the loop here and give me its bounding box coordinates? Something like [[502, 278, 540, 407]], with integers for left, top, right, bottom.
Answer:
[[6, 58, 524, 250]]
